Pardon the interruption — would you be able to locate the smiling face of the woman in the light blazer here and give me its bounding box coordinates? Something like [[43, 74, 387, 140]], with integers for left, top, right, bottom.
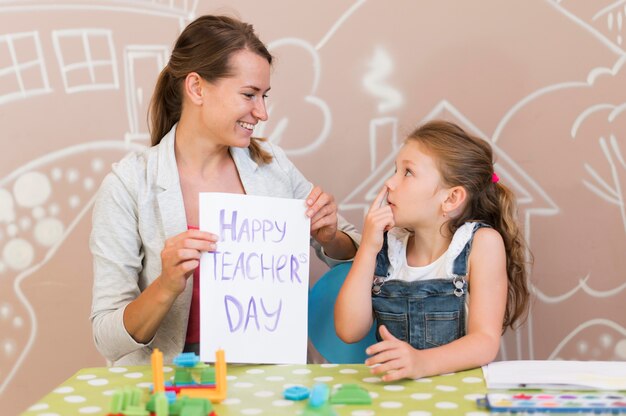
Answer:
[[202, 50, 270, 147]]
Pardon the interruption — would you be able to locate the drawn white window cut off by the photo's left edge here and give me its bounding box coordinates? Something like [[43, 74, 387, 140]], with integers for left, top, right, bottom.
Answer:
[[0, 32, 51, 104]]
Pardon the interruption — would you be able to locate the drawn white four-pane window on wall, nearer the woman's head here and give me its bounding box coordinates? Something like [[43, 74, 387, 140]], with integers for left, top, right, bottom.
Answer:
[[52, 29, 119, 94]]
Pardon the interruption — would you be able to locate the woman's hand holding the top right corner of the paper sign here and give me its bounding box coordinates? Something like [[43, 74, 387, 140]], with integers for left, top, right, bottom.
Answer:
[[306, 186, 337, 244]]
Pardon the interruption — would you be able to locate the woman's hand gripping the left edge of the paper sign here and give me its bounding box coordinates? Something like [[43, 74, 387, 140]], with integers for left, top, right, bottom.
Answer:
[[160, 230, 217, 296]]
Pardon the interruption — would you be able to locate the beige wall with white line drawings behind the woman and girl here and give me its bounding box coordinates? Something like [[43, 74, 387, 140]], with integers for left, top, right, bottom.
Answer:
[[0, 0, 626, 414]]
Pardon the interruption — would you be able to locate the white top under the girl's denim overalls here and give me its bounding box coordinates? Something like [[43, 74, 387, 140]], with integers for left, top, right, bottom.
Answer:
[[387, 222, 478, 282]]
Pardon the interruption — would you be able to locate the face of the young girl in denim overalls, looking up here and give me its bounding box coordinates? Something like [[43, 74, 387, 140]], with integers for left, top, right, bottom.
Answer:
[[385, 140, 447, 230]]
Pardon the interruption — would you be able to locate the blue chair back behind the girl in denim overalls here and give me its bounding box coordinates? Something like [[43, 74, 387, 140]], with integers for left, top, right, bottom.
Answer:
[[309, 262, 377, 364]]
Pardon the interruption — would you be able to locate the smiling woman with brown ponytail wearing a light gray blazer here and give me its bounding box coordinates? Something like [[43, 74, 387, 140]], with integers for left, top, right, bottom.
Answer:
[[90, 16, 358, 365]]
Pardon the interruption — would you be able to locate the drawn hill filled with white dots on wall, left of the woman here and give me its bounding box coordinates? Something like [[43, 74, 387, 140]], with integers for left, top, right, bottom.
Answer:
[[0, 140, 145, 393]]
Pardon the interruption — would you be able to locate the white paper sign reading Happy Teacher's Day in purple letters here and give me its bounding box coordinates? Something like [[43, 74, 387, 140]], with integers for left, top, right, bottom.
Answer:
[[200, 193, 310, 364]]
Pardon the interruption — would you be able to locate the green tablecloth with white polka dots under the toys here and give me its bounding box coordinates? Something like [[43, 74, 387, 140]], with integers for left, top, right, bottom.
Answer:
[[22, 364, 488, 416]]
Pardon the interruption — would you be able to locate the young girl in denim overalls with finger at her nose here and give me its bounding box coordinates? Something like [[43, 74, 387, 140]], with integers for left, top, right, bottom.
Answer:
[[335, 121, 528, 381]]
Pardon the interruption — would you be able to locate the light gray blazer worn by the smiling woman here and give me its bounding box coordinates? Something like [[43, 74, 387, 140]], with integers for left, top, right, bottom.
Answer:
[[89, 126, 360, 365]]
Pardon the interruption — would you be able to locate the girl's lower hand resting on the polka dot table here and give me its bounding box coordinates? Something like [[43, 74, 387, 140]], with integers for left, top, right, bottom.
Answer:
[[365, 325, 420, 381]]
